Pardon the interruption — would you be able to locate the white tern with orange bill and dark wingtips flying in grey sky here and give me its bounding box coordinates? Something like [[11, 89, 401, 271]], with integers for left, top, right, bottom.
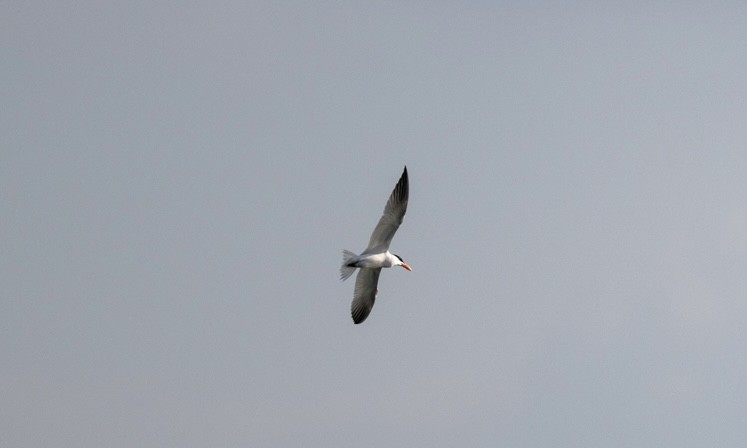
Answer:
[[340, 167, 412, 324]]
